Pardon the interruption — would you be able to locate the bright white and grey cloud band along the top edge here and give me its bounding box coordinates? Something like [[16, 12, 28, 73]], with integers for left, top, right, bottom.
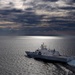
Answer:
[[0, 0, 75, 11]]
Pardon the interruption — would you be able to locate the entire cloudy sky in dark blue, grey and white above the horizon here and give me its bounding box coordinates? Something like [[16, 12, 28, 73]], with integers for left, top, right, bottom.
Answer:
[[0, 0, 75, 36]]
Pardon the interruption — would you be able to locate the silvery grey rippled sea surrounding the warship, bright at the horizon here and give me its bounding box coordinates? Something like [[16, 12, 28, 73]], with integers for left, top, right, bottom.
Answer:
[[0, 36, 75, 75]]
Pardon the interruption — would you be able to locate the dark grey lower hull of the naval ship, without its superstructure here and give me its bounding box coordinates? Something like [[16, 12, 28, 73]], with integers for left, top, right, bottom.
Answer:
[[26, 51, 68, 63]]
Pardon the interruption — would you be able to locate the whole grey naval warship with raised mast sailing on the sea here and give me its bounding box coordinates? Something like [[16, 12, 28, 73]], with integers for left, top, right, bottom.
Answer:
[[25, 43, 73, 63]]
